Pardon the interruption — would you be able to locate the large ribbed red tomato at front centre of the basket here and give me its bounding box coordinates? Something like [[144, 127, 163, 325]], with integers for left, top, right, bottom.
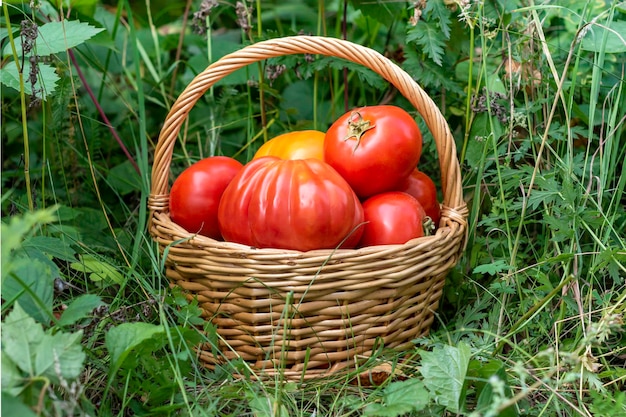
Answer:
[[218, 156, 363, 251]]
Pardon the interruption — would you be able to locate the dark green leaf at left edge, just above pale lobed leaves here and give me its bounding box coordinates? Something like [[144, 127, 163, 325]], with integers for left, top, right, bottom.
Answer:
[[2, 257, 56, 323]]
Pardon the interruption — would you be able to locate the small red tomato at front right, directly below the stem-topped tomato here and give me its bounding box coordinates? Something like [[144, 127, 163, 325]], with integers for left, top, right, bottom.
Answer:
[[359, 191, 426, 246]]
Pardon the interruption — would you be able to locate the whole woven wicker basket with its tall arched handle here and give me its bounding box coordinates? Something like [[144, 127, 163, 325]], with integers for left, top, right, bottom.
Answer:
[[148, 36, 467, 381]]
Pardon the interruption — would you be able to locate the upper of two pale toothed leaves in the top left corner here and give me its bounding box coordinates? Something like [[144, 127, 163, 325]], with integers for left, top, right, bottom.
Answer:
[[3, 20, 104, 56]]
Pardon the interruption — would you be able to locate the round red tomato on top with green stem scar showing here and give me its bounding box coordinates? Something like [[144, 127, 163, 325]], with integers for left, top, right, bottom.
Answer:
[[324, 106, 422, 198]]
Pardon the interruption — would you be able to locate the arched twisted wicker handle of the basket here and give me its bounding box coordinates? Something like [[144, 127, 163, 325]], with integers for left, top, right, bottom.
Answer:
[[148, 35, 466, 220]]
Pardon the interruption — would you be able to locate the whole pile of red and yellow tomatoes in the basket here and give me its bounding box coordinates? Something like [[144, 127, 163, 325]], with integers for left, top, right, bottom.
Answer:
[[170, 106, 440, 251]]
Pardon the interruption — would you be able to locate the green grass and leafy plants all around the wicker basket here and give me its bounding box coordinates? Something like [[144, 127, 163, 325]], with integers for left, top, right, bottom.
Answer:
[[0, 0, 626, 417]]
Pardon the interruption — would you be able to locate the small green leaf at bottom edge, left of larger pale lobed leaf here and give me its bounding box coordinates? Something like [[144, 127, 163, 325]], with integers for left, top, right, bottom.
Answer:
[[363, 378, 431, 417]]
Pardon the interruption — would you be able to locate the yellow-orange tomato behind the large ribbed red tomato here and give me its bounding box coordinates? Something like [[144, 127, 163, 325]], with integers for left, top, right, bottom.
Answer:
[[253, 130, 325, 161]]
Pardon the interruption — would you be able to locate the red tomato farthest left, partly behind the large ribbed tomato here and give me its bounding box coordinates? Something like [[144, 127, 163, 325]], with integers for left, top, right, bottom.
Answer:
[[170, 156, 243, 239]]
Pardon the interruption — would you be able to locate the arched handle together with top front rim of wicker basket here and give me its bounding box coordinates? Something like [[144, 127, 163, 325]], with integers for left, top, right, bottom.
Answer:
[[148, 35, 468, 254]]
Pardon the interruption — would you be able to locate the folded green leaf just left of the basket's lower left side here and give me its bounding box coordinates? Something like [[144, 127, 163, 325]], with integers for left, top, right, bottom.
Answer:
[[104, 323, 165, 369]]
